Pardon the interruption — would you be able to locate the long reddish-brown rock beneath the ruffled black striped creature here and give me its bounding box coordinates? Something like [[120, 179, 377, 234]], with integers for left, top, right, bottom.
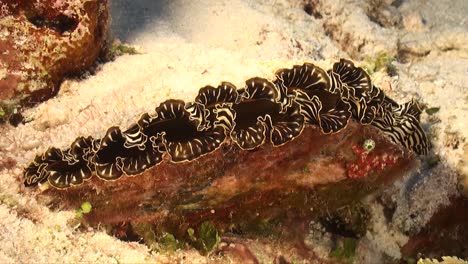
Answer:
[[39, 122, 417, 234]]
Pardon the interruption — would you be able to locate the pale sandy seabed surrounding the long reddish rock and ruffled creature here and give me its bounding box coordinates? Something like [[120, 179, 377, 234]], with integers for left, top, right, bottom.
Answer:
[[0, 0, 468, 263]]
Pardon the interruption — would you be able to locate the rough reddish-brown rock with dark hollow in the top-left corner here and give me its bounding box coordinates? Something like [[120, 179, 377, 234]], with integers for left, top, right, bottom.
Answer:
[[0, 0, 108, 104]]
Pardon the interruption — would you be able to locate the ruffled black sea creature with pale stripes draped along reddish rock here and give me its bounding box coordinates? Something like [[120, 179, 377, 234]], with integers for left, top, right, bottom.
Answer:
[[24, 59, 430, 189]]
